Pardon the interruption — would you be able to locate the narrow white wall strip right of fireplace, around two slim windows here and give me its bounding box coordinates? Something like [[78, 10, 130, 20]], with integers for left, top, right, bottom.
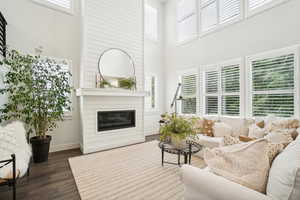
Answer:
[[144, 0, 165, 135]]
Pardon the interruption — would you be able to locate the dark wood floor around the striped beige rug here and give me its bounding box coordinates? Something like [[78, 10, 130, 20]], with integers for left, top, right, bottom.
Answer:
[[0, 135, 158, 200]]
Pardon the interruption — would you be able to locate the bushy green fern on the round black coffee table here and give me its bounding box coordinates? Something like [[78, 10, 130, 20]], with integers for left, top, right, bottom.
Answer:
[[159, 114, 199, 148]]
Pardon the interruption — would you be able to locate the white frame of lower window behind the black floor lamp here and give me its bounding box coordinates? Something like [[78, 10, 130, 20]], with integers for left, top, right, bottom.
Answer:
[[177, 68, 200, 116]]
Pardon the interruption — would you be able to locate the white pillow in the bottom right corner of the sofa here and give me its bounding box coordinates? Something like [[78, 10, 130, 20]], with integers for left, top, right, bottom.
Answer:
[[267, 132, 300, 200]]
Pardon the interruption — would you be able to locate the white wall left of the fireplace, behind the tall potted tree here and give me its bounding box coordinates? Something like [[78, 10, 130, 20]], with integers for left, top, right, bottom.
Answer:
[[0, 0, 80, 151]]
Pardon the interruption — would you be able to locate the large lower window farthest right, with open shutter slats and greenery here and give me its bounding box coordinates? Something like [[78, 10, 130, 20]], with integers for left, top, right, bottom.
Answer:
[[249, 48, 296, 117]]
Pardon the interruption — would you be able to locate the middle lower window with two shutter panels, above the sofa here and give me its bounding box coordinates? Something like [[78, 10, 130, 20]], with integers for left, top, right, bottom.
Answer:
[[204, 61, 240, 116]]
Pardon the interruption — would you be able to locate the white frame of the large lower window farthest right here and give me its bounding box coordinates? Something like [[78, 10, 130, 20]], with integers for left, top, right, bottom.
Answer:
[[246, 45, 300, 118]]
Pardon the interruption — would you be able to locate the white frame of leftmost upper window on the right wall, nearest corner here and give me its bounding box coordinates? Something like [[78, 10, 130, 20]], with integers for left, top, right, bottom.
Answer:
[[176, 0, 199, 45]]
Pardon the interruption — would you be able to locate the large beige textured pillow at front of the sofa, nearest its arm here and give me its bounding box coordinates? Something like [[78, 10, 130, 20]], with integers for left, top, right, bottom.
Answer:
[[204, 139, 270, 193]]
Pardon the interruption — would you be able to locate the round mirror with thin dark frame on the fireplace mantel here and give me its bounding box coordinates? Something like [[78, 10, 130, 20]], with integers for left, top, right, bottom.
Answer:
[[98, 48, 136, 89]]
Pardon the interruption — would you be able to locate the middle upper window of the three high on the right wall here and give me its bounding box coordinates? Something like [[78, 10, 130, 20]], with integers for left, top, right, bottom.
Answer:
[[199, 0, 242, 33]]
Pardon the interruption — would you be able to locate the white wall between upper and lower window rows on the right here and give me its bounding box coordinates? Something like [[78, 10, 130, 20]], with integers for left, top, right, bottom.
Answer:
[[165, 0, 300, 113]]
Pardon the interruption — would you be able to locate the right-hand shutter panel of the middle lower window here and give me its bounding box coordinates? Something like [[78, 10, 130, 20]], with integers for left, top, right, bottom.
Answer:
[[221, 65, 240, 116]]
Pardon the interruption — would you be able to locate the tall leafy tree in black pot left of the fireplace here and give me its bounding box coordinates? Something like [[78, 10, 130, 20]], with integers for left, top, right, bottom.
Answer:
[[0, 50, 71, 162]]
